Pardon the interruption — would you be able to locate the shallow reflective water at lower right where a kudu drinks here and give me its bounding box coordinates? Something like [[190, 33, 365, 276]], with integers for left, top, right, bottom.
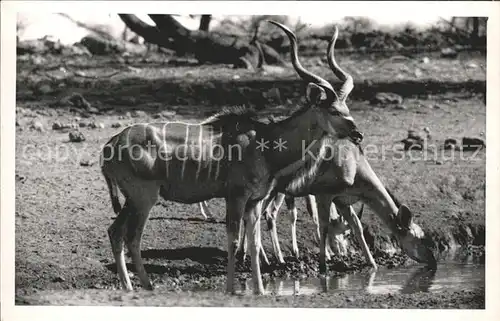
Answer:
[[240, 257, 485, 295]]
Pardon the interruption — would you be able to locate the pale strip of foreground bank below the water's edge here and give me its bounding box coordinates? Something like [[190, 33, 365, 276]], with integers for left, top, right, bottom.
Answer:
[[16, 288, 485, 309]]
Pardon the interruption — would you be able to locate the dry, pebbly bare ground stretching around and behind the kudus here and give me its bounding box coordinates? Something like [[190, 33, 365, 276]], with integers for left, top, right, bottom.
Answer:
[[15, 51, 486, 308]]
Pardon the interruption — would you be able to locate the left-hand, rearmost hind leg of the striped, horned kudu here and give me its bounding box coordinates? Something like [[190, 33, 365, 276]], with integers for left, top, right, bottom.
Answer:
[[108, 202, 133, 291]]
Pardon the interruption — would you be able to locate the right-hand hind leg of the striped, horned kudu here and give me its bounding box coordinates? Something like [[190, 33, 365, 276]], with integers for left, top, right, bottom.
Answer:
[[122, 183, 159, 290]]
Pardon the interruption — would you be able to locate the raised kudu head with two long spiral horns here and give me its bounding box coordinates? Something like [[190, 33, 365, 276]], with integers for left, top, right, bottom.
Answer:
[[268, 20, 363, 143]]
